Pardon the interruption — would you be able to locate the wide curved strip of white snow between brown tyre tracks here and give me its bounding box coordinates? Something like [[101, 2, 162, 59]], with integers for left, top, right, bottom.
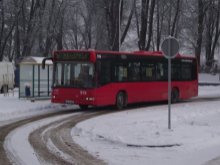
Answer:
[[4, 114, 75, 165]]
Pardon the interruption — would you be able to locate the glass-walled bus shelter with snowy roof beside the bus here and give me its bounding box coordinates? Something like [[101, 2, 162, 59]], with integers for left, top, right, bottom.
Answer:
[[19, 56, 53, 99]]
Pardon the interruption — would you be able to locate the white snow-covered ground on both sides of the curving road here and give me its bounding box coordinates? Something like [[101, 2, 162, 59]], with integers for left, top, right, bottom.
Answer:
[[0, 74, 220, 165]]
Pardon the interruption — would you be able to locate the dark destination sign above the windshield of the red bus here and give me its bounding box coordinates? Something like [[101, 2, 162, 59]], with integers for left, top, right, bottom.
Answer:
[[54, 52, 90, 61]]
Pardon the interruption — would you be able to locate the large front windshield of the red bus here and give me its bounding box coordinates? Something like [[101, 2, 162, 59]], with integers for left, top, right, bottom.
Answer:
[[53, 62, 95, 88]]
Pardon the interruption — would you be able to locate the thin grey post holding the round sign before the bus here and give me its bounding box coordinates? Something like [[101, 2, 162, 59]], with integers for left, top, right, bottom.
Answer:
[[168, 40, 171, 129]]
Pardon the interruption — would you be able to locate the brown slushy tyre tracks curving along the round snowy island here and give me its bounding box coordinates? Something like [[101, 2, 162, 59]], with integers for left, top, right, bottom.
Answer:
[[29, 111, 109, 165]]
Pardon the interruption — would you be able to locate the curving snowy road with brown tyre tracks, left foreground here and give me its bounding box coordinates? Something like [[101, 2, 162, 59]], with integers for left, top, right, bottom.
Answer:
[[0, 108, 109, 165]]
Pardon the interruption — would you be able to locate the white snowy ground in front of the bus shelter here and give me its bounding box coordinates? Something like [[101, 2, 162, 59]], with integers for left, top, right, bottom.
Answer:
[[0, 88, 76, 125]]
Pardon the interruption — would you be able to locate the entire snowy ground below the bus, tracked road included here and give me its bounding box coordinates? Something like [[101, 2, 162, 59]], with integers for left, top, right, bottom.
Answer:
[[0, 83, 220, 165]]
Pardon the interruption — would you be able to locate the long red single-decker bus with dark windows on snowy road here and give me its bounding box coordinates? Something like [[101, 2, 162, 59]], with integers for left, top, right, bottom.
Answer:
[[43, 50, 198, 109]]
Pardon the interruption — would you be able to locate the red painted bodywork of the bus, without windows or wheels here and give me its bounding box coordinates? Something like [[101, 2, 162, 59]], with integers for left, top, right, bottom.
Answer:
[[48, 50, 198, 106]]
